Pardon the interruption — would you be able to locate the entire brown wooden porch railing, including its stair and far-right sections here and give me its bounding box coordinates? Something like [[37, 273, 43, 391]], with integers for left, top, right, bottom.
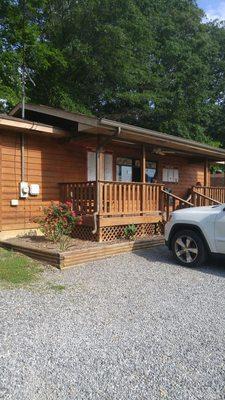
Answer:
[[60, 181, 225, 220]]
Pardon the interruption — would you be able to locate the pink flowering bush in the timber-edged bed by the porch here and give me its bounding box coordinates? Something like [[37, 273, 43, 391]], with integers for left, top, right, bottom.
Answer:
[[36, 201, 81, 251]]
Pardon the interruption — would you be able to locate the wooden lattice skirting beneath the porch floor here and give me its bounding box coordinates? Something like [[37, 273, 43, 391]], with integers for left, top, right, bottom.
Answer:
[[73, 223, 163, 242]]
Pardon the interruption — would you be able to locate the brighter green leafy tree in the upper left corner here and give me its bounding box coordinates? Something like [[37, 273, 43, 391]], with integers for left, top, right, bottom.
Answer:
[[0, 0, 64, 111]]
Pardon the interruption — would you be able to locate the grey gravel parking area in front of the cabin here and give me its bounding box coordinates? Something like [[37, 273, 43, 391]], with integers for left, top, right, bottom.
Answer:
[[0, 246, 225, 400]]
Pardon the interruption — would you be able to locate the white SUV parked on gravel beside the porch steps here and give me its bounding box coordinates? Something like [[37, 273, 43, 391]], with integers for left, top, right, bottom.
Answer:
[[165, 204, 225, 267]]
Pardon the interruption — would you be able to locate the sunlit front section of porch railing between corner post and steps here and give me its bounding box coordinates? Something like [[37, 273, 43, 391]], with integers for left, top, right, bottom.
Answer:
[[99, 181, 163, 216]]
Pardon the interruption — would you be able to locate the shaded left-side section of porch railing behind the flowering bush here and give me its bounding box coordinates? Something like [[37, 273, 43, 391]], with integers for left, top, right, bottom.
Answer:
[[59, 182, 97, 215]]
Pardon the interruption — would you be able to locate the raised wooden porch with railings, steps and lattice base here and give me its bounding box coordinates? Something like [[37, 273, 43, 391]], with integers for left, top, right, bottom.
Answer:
[[59, 181, 225, 241]]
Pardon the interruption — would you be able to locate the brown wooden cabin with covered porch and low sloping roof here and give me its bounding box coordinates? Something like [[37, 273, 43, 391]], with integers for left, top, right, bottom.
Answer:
[[0, 104, 225, 241]]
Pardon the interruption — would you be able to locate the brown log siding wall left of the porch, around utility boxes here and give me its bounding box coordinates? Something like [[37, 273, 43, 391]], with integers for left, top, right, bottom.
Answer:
[[0, 132, 86, 231]]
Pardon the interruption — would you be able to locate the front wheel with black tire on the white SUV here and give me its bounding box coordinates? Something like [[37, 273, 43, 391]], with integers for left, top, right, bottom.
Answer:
[[171, 230, 207, 268]]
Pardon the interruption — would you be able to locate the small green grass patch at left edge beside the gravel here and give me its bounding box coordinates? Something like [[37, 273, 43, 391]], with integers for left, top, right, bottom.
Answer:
[[0, 249, 42, 285]]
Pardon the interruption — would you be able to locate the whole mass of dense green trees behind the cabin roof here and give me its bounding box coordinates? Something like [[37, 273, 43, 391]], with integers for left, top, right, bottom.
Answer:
[[0, 0, 225, 145]]
